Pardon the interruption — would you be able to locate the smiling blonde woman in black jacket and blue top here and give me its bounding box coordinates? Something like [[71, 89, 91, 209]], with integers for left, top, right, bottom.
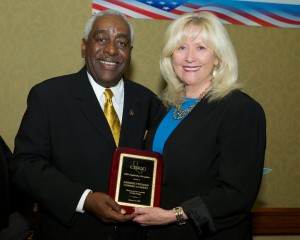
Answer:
[[134, 12, 266, 240]]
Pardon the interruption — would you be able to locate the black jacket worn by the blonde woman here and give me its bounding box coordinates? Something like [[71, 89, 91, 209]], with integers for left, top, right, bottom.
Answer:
[[146, 91, 266, 240]]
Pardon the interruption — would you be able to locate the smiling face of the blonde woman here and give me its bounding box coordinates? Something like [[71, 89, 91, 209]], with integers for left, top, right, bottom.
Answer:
[[172, 34, 218, 90]]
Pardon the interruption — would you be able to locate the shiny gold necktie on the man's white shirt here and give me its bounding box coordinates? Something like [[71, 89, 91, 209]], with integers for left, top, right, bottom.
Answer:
[[104, 88, 121, 146]]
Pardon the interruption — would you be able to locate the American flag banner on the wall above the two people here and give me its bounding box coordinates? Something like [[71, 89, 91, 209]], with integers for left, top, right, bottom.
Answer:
[[92, 0, 300, 28]]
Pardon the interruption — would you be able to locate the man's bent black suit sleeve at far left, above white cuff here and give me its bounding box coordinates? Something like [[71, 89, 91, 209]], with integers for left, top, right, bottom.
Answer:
[[12, 87, 85, 224]]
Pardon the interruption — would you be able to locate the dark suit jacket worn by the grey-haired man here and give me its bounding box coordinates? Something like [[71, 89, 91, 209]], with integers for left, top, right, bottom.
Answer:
[[12, 68, 159, 240]]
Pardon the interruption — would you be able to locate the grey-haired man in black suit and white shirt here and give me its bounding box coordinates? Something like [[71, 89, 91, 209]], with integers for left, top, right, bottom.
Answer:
[[12, 11, 159, 240]]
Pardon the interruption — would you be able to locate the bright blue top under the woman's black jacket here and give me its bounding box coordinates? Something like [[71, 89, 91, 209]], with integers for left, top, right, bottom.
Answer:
[[152, 98, 197, 154]]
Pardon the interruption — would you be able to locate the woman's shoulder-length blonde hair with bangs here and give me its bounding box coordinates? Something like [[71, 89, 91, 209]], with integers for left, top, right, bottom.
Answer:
[[160, 11, 240, 106]]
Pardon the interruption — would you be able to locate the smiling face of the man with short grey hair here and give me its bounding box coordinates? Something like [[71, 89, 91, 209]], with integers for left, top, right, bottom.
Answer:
[[81, 15, 132, 88]]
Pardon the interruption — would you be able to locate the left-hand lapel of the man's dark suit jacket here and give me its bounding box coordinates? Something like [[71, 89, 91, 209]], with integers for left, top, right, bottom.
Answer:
[[73, 68, 115, 146]]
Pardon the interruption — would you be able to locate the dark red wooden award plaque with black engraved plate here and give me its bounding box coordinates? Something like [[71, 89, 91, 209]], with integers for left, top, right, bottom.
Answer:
[[109, 148, 163, 213]]
